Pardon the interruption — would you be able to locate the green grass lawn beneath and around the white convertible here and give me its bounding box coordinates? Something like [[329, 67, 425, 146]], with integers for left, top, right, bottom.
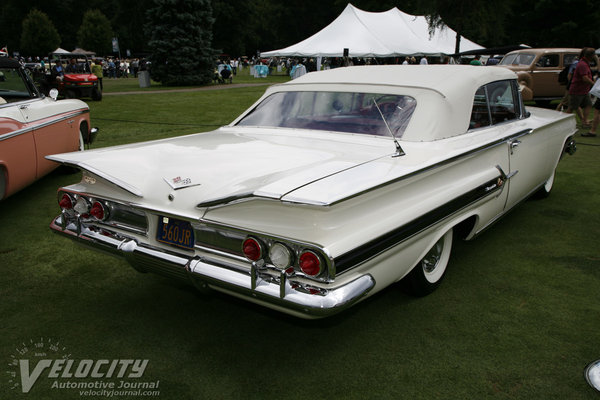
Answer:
[[0, 81, 600, 400]]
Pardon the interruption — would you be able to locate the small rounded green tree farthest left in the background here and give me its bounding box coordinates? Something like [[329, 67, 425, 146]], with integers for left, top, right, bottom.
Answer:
[[21, 8, 60, 56]]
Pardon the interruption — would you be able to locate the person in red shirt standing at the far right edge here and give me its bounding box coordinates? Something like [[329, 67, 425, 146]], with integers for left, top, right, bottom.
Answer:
[[567, 47, 595, 131]]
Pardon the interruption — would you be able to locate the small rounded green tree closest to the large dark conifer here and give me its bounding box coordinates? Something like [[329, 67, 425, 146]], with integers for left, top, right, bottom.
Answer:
[[77, 10, 113, 55]]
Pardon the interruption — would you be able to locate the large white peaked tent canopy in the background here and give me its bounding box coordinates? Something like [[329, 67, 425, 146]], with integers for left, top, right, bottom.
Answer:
[[261, 4, 483, 57]]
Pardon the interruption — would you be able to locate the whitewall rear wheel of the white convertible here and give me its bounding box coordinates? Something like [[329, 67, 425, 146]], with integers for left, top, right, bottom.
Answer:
[[403, 229, 453, 296]]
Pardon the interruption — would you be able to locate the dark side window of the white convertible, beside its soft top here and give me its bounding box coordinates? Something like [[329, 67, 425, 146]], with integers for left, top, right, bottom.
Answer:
[[469, 80, 520, 129]]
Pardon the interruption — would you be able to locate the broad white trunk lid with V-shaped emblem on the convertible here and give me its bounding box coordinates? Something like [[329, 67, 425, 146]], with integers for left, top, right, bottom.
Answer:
[[48, 128, 394, 211]]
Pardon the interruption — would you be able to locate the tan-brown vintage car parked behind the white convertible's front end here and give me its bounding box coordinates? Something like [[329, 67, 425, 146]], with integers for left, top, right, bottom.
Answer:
[[498, 48, 581, 105]]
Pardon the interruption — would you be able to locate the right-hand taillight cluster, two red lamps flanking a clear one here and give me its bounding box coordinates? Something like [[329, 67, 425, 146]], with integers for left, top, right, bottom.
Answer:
[[242, 237, 325, 277]]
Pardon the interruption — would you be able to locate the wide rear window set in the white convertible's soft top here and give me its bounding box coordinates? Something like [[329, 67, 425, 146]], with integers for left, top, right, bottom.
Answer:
[[237, 92, 416, 138]]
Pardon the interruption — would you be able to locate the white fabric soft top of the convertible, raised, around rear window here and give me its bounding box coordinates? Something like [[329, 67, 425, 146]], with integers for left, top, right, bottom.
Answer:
[[233, 65, 516, 142]]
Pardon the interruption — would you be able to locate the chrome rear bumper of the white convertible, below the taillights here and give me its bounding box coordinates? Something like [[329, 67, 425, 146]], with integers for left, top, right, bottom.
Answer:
[[50, 216, 375, 318]]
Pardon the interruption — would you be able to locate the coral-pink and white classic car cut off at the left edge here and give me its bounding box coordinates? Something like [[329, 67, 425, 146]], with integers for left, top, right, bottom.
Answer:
[[0, 57, 96, 200]]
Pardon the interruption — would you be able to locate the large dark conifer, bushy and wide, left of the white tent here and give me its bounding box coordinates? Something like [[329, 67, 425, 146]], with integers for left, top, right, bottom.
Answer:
[[147, 0, 215, 85]]
